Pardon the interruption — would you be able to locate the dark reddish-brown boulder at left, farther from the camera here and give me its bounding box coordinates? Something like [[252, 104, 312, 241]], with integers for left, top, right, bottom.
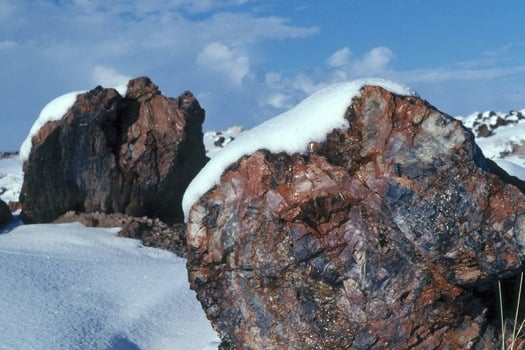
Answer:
[[20, 78, 207, 223]]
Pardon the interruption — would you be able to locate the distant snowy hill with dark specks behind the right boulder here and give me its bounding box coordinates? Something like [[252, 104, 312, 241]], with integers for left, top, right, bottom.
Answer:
[[458, 109, 525, 180]]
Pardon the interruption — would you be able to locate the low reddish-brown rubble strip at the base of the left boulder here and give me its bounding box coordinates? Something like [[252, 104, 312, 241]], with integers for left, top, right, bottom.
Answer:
[[54, 211, 186, 257]]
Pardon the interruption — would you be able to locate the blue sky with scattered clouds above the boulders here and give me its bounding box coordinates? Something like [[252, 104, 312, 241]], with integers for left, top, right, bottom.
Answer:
[[0, 0, 525, 151]]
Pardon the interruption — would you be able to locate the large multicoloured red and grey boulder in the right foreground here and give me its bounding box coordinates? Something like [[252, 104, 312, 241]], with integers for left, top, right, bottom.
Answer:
[[186, 87, 525, 349]]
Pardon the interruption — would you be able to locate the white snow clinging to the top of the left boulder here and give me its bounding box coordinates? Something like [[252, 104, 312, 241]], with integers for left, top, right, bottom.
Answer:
[[20, 84, 127, 160]]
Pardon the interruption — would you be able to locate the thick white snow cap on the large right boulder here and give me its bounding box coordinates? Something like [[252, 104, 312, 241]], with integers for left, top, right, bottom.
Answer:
[[182, 78, 415, 220]]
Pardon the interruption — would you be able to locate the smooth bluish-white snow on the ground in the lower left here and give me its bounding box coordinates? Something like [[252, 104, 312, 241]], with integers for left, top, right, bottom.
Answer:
[[0, 223, 219, 350]]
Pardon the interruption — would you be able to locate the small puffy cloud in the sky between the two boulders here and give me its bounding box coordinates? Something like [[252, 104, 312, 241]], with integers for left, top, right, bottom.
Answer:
[[197, 42, 250, 85]]
